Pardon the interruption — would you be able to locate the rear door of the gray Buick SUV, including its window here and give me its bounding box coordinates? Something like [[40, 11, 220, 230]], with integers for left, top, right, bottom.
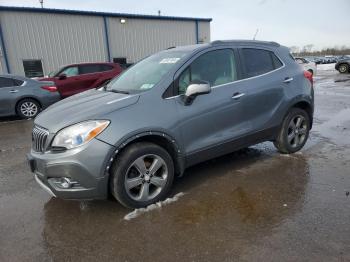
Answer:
[[239, 47, 286, 132]]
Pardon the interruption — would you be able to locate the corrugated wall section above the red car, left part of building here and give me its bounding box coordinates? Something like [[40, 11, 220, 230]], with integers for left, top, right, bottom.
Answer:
[[0, 12, 106, 75]]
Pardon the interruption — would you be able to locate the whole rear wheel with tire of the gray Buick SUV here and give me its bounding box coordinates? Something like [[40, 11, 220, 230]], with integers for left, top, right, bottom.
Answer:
[[274, 108, 310, 154]]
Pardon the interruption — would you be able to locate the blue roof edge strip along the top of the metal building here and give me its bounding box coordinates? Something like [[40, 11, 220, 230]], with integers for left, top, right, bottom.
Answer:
[[0, 6, 212, 22]]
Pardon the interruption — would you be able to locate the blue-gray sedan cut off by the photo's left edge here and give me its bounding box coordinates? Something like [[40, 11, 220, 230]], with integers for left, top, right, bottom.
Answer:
[[0, 75, 60, 118]]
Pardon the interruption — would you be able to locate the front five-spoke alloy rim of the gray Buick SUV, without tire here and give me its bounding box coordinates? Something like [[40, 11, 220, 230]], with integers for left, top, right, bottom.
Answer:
[[124, 154, 168, 202]]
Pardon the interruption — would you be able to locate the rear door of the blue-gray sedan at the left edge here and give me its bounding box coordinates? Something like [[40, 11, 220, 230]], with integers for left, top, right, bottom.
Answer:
[[0, 77, 23, 115]]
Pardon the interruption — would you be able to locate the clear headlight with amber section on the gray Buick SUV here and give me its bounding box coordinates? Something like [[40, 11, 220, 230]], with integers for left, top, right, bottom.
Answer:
[[52, 120, 110, 149]]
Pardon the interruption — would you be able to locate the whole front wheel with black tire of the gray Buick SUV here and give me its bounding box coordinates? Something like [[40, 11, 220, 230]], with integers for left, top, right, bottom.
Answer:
[[110, 142, 174, 208]]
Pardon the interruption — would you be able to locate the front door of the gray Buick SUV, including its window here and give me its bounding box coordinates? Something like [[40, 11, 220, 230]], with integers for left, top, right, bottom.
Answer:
[[175, 48, 251, 164]]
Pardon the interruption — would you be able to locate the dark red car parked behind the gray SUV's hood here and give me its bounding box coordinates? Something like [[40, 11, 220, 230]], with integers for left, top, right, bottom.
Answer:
[[38, 63, 122, 98]]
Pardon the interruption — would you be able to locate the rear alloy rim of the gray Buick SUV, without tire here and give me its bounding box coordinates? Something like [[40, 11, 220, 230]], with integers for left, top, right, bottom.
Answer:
[[287, 115, 308, 148]]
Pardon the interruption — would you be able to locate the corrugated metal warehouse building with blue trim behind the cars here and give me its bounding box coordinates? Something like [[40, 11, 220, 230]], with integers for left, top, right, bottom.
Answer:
[[0, 6, 212, 77]]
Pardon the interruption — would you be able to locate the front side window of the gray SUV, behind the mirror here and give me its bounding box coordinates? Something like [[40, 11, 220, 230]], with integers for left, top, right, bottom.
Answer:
[[178, 49, 237, 94]]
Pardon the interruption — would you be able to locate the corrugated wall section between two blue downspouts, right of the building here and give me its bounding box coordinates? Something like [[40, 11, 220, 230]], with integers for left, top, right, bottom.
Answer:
[[107, 17, 196, 63]]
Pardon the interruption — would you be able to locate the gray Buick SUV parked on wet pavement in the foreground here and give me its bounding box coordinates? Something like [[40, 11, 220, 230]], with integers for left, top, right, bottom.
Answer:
[[28, 41, 314, 208]]
